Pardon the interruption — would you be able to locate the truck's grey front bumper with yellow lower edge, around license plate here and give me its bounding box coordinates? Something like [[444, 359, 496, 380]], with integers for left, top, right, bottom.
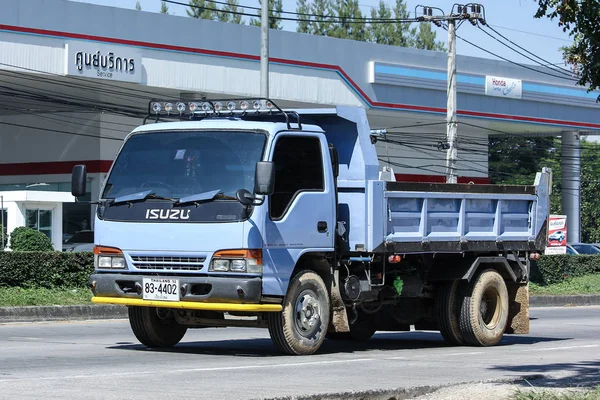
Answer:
[[90, 273, 282, 312]]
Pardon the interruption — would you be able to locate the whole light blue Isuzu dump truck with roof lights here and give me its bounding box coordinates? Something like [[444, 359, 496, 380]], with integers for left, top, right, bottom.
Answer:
[[72, 99, 551, 354]]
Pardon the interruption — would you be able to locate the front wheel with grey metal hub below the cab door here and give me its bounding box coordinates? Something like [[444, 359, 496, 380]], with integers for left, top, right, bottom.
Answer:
[[267, 270, 330, 355]]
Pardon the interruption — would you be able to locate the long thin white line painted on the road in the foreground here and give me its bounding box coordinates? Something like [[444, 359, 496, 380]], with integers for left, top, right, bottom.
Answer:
[[0, 358, 376, 383]]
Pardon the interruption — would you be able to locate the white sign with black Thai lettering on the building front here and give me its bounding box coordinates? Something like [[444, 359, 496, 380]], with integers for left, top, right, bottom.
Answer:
[[65, 42, 142, 83]]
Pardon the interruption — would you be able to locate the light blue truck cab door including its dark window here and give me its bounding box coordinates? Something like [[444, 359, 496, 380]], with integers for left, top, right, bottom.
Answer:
[[263, 133, 335, 295]]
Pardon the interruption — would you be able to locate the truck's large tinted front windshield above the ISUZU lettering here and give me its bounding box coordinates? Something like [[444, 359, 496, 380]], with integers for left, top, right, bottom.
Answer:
[[102, 131, 266, 199]]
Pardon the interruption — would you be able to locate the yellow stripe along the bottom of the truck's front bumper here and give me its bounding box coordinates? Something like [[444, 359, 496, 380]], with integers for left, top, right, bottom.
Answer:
[[92, 296, 282, 312]]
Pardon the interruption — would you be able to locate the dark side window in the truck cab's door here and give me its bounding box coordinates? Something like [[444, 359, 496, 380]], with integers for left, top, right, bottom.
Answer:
[[269, 136, 325, 220]]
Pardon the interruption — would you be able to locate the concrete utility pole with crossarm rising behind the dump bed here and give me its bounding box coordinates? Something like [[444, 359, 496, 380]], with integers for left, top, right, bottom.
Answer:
[[415, 3, 486, 183]]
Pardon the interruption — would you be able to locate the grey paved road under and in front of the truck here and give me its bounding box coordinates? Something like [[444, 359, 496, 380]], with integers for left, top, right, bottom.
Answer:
[[0, 307, 600, 400]]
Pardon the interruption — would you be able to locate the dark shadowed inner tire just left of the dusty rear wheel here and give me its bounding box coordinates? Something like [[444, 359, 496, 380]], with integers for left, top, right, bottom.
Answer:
[[435, 281, 465, 346]]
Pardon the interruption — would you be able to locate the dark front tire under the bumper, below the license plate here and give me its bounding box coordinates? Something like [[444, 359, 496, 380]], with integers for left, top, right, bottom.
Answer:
[[128, 306, 187, 348]]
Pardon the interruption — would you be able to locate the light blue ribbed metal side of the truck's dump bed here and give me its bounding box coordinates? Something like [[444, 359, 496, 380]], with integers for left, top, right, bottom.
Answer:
[[366, 172, 550, 253]]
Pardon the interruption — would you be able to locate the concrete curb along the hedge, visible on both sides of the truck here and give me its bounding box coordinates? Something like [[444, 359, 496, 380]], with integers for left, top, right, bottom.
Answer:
[[0, 295, 600, 323]]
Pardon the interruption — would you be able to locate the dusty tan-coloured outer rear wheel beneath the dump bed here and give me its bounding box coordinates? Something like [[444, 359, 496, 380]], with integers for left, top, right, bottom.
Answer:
[[460, 269, 508, 346]]
